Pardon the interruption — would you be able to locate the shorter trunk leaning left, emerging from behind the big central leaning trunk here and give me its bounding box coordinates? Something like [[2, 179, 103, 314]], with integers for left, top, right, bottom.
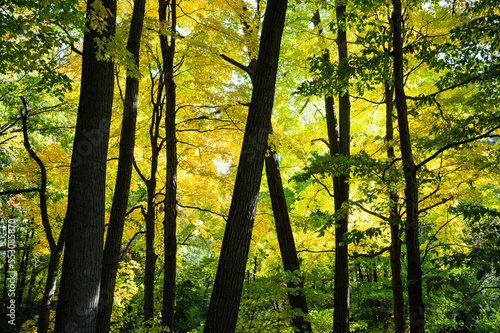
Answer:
[[265, 147, 312, 332]]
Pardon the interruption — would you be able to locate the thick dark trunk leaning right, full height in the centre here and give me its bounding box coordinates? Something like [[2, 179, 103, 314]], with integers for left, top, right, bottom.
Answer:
[[204, 0, 287, 333]]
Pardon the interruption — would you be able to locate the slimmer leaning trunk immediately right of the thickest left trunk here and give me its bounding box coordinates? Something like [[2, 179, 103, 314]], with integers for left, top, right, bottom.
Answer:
[[97, 0, 146, 333]]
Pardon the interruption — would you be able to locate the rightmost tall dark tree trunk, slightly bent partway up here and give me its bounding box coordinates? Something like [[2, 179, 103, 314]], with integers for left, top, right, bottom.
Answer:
[[392, 0, 425, 333]]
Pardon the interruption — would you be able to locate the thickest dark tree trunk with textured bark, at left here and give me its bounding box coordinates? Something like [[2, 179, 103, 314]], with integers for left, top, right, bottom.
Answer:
[[55, 0, 116, 333]]
